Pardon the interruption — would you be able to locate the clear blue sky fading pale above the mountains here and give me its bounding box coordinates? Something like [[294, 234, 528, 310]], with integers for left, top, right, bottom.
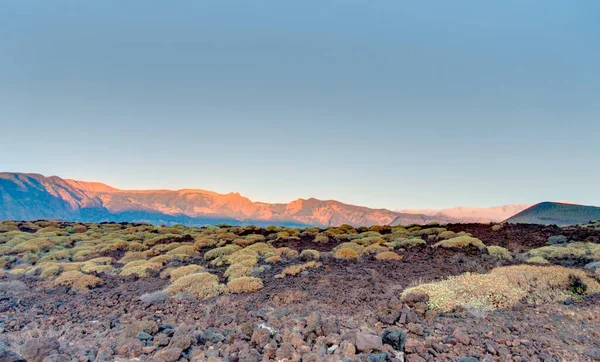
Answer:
[[0, 0, 600, 210]]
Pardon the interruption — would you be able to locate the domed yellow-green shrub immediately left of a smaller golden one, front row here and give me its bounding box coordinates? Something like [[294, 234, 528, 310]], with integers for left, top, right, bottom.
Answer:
[[165, 273, 227, 300]]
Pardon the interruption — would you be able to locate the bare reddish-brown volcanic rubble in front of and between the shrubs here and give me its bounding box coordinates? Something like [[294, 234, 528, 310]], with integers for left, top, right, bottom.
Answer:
[[0, 224, 600, 362]]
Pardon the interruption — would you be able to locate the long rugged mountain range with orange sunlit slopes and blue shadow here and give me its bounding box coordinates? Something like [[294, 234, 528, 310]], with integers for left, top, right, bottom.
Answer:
[[0, 172, 456, 226]]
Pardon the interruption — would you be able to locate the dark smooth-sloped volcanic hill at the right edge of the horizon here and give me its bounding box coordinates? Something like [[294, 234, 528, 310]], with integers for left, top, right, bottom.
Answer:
[[506, 202, 600, 225]]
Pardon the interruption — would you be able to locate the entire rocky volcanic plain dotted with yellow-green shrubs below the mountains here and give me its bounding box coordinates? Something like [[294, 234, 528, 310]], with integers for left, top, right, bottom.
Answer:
[[0, 221, 600, 362]]
